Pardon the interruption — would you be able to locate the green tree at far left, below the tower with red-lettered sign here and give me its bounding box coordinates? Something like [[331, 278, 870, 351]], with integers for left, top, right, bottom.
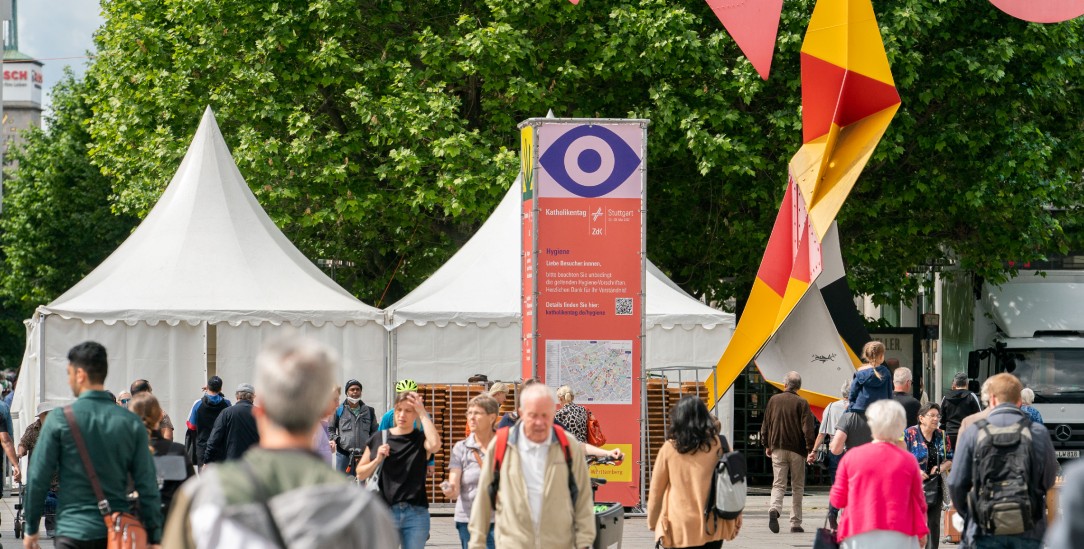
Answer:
[[0, 72, 137, 368]]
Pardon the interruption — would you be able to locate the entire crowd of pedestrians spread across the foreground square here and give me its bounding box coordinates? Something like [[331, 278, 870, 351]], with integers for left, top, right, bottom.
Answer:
[[0, 336, 1084, 549]]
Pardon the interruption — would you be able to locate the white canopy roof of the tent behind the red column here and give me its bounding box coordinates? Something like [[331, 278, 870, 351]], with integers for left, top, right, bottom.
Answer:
[[387, 178, 734, 329]]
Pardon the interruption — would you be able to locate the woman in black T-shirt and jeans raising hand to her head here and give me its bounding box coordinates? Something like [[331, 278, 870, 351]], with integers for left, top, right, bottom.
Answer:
[[358, 392, 441, 549]]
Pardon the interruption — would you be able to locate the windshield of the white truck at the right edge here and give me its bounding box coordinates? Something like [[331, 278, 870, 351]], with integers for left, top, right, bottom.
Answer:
[[1002, 348, 1084, 403]]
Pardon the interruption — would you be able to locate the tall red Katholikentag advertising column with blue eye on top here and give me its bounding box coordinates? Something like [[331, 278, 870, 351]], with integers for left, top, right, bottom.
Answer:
[[520, 118, 648, 506]]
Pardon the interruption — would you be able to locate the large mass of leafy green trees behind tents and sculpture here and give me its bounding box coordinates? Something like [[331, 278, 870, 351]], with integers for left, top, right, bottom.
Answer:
[[84, 0, 1084, 305]]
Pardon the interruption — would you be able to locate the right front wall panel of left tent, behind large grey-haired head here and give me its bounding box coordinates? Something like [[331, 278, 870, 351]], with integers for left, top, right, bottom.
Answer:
[[213, 321, 390, 412]]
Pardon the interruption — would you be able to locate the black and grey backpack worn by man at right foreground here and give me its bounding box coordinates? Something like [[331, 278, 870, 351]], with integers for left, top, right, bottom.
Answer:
[[968, 416, 1043, 536]]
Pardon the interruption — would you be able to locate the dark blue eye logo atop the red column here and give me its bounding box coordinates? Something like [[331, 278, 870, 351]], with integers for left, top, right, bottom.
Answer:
[[539, 126, 641, 199]]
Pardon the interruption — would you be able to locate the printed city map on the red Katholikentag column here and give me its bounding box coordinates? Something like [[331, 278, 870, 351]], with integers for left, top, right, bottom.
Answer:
[[545, 340, 632, 404]]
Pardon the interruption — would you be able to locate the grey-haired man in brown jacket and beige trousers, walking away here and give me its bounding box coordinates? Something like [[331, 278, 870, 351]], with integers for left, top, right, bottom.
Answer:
[[760, 372, 816, 534]]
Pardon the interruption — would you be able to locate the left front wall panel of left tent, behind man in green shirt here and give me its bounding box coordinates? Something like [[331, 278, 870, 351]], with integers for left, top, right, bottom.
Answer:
[[29, 315, 207, 431]]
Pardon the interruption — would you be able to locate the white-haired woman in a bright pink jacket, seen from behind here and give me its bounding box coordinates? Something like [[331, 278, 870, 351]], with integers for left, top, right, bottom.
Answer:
[[828, 399, 930, 549]]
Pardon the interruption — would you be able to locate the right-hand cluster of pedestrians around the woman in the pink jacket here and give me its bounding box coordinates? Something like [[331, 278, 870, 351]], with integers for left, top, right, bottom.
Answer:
[[761, 342, 1066, 549]]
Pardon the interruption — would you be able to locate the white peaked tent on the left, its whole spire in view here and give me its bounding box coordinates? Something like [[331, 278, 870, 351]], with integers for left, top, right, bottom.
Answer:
[[14, 108, 387, 429]]
